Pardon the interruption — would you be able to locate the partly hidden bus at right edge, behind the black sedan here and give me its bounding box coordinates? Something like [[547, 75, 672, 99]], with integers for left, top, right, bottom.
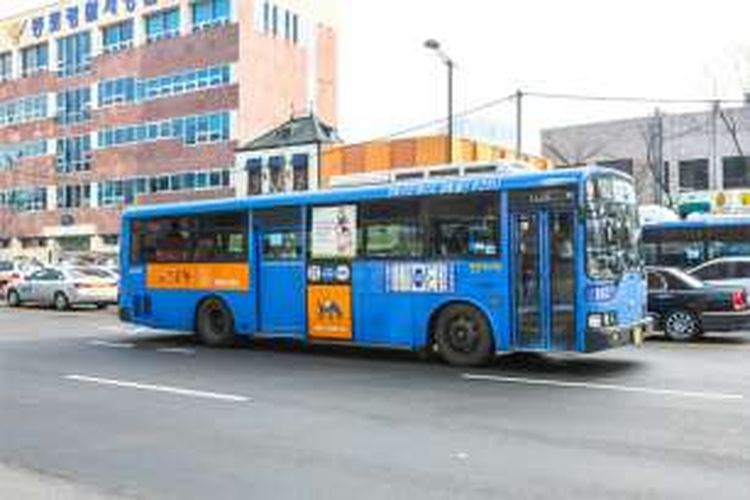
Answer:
[[643, 216, 750, 269]]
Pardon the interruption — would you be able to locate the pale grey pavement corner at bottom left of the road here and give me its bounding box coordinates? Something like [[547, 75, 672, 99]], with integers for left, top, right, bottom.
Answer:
[[0, 464, 130, 500]]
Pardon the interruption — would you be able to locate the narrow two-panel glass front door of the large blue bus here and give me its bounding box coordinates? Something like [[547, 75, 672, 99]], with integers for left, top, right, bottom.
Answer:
[[510, 193, 576, 351]]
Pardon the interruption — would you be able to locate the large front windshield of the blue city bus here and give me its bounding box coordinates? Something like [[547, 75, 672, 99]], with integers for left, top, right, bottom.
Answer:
[[586, 175, 642, 279]]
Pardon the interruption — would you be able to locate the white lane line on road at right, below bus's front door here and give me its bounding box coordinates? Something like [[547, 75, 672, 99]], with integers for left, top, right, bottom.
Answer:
[[461, 373, 744, 401]]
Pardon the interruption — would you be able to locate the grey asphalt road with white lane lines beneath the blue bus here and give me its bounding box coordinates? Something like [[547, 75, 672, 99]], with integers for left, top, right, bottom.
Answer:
[[0, 308, 750, 500]]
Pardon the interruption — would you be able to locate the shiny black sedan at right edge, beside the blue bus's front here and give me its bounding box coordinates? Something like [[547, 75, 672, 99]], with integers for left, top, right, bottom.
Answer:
[[646, 267, 750, 340]]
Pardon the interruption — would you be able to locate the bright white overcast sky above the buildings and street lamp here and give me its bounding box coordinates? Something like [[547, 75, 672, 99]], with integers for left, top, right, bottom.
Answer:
[[0, 0, 750, 153]]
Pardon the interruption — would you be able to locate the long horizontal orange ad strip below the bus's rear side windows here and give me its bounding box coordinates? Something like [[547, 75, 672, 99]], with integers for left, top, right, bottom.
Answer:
[[146, 263, 250, 292]]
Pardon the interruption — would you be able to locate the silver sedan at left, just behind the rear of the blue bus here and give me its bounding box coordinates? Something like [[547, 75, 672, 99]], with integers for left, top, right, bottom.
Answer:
[[7, 267, 117, 311]]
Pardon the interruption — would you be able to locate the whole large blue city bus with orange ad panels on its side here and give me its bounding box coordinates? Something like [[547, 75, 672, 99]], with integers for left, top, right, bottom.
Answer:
[[119, 167, 648, 366]]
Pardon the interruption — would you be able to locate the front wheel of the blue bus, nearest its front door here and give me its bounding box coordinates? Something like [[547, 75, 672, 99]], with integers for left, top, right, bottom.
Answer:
[[434, 304, 495, 366]]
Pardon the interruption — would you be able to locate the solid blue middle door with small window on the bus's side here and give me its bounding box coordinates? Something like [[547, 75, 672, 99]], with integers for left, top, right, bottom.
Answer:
[[253, 211, 305, 336]]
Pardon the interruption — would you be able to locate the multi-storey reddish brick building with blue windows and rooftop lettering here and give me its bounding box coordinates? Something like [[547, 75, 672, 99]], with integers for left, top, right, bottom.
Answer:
[[0, 0, 337, 261]]
